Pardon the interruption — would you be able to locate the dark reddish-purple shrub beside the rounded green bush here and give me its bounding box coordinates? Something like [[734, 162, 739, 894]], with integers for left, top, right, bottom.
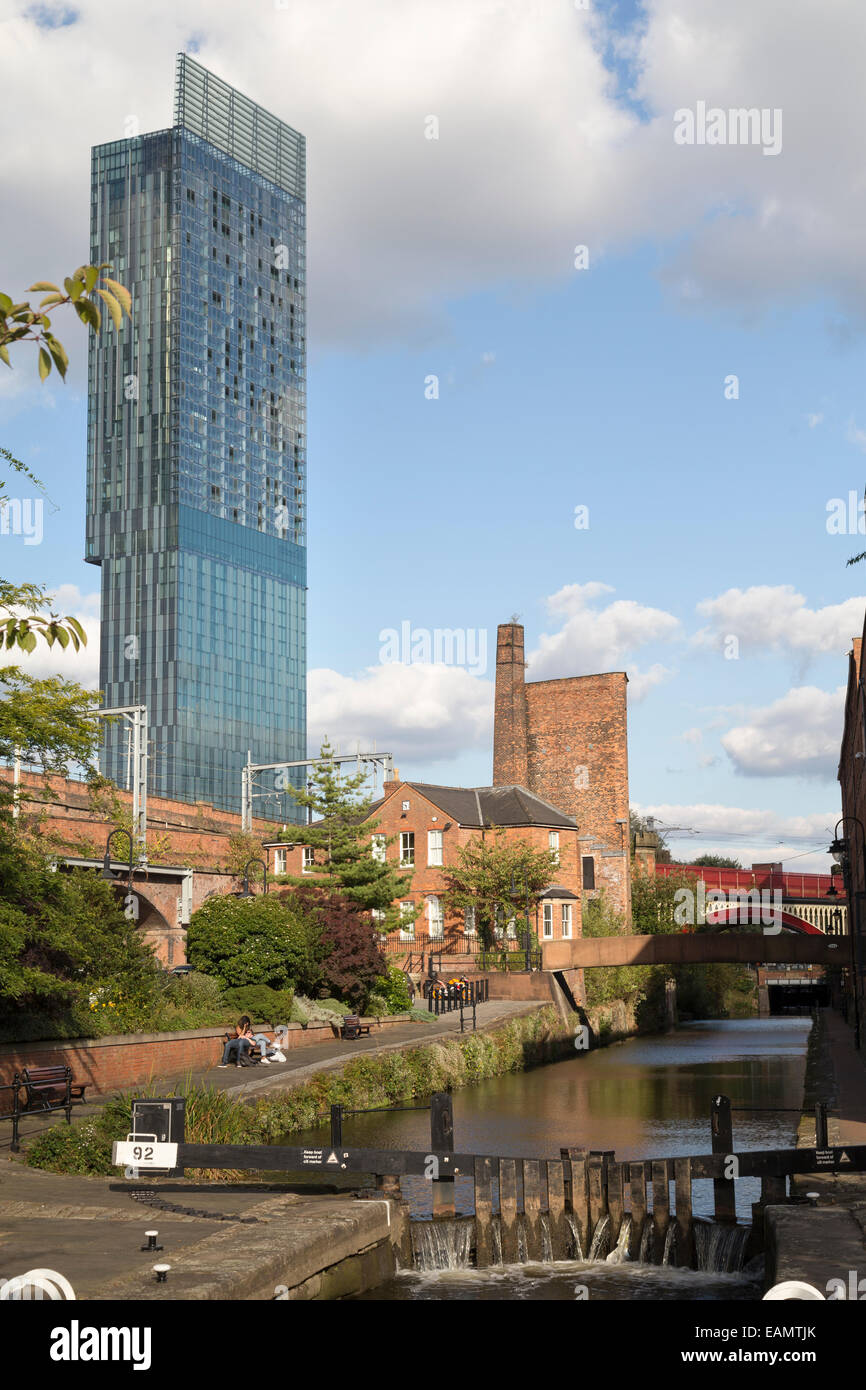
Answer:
[[281, 883, 388, 1012]]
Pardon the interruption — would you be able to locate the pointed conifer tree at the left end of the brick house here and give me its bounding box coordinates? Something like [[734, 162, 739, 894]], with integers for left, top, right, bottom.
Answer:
[[279, 739, 411, 931]]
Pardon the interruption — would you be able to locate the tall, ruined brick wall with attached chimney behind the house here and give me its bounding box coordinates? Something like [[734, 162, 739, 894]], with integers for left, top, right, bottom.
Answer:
[[493, 623, 631, 920]]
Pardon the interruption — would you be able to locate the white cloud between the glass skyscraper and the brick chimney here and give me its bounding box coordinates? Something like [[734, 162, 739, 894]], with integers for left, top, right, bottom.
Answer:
[[307, 663, 493, 773]]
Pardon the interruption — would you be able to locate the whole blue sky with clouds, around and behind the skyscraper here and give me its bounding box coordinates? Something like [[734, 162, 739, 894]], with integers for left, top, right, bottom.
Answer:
[[0, 0, 866, 867]]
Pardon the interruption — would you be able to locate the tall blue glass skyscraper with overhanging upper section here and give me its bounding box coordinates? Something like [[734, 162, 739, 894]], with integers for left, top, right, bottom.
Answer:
[[86, 54, 307, 820]]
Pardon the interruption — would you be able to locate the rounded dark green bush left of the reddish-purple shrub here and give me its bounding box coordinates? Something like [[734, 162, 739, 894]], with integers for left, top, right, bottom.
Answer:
[[186, 894, 325, 991]]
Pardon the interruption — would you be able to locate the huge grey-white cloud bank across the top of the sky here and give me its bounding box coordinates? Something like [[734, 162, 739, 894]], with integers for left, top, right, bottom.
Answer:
[[4, 0, 866, 373]]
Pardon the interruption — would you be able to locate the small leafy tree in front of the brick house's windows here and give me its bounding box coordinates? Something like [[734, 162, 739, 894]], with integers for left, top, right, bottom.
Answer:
[[445, 827, 559, 947]]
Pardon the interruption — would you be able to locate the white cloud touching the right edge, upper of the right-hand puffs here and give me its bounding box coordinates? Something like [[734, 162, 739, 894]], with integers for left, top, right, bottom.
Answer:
[[692, 584, 866, 656]]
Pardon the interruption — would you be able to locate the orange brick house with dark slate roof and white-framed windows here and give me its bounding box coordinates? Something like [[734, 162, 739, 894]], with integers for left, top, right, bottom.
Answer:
[[265, 781, 581, 969]]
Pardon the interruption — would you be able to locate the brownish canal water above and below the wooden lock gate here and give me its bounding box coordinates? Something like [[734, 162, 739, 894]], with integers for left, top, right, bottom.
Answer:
[[322, 1017, 810, 1300]]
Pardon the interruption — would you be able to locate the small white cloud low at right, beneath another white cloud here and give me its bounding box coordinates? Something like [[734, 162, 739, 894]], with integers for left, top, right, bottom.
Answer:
[[721, 685, 845, 780]]
